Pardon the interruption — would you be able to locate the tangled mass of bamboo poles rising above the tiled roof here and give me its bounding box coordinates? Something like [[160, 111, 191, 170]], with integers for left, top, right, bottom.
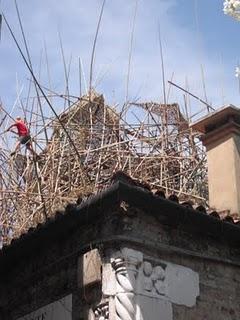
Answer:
[[0, 90, 208, 243]]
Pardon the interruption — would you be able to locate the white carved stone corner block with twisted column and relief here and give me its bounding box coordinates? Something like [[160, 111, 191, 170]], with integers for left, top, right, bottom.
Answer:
[[106, 248, 199, 320]]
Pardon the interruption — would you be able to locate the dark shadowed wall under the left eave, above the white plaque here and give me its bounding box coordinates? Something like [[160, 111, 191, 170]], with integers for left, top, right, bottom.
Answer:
[[0, 236, 81, 320]]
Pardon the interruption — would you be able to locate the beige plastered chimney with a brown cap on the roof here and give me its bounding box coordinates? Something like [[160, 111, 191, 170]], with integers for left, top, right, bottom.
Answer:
[[191, 105, 240, 215]]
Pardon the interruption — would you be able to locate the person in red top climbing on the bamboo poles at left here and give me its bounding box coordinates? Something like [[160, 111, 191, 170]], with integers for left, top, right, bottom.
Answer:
[[6, 117, 38, 159]]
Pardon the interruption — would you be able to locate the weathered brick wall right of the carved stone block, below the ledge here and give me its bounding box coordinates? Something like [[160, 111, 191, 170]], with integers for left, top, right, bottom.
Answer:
[[173, 259, 240, 320]]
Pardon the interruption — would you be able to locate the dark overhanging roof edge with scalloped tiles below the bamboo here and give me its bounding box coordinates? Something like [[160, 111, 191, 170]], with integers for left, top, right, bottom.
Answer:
[[0, 172, 240, 271]]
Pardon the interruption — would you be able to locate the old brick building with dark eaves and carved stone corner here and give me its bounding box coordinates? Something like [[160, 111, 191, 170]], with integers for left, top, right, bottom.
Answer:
[[0, 107, 240, 320]]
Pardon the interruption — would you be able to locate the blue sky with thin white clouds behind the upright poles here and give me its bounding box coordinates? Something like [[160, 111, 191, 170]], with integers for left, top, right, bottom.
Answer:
[[0, 0, 240, 120]]
